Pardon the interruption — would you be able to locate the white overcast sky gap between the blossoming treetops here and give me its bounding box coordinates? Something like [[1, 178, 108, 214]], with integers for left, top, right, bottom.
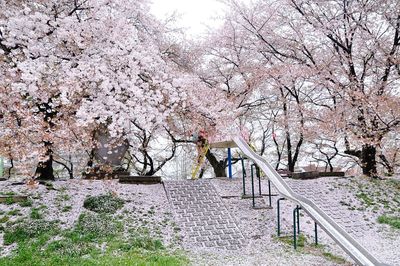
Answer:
[[151, 0, 224, 36]]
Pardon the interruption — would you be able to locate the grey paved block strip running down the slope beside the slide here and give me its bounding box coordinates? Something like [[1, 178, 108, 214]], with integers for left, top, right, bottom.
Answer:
[[164, 180, 245, 250]]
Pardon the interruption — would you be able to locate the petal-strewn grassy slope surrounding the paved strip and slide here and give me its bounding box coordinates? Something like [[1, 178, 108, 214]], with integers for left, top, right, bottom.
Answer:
[[0, 177, 400, 266]]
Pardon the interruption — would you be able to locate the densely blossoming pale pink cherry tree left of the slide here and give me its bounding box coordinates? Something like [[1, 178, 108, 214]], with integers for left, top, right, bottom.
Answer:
[[0, 0, 238, 179]]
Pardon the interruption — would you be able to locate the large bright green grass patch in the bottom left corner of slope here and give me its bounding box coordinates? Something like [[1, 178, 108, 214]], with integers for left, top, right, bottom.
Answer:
[[0, 212, 188, 266]]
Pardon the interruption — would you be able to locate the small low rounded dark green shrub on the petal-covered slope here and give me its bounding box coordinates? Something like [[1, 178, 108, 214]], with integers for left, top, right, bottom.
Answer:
[[83, 194, 124, 213]]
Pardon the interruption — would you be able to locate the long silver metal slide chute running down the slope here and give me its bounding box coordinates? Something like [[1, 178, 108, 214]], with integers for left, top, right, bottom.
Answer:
[[233, 137, 385, 266]]
